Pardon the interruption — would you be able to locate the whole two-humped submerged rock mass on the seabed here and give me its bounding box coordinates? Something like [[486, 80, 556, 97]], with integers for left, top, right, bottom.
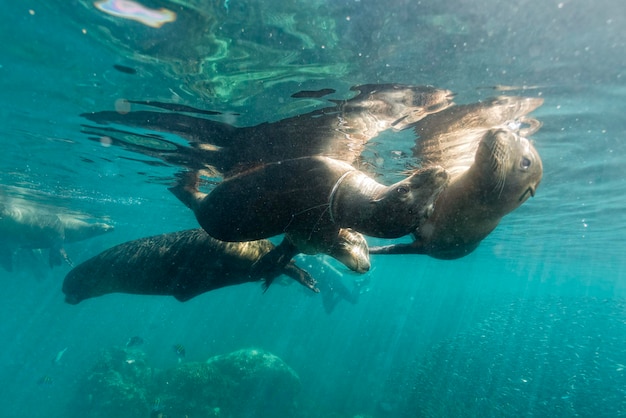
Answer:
[[68, 348, 300, 418]]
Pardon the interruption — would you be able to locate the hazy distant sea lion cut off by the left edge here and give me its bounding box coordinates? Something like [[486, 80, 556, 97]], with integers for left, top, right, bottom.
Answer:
[[0, 204, 113, 271]]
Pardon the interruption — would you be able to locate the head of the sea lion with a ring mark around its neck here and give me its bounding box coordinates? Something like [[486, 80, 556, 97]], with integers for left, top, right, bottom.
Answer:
[[368, 166, 449, 238]]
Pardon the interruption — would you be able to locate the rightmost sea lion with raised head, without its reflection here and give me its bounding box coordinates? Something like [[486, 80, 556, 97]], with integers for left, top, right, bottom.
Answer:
[[370, 129, 543, 259]]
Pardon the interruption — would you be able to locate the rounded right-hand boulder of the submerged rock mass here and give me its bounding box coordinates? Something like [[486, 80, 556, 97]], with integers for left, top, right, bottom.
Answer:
[[155, 349, 300, 418]]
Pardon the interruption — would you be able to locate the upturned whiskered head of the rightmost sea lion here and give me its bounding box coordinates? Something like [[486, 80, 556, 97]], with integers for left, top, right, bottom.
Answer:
[[473, 129, 543, 212]]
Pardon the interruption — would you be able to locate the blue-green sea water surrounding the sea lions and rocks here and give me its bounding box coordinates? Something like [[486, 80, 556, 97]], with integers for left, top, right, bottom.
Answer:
[[0, 0, 626, 417]]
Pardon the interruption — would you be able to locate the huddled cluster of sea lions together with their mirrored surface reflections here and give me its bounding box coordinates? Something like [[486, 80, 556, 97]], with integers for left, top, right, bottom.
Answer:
[[63, 84, 543, 303]]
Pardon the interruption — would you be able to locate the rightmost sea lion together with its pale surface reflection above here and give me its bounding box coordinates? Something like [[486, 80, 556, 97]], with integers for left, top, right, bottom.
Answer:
[[370, 97, 543, 259]]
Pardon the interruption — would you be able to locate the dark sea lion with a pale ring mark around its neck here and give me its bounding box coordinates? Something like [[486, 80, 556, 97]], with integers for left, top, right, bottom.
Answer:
[[170, 156, 447, 284]]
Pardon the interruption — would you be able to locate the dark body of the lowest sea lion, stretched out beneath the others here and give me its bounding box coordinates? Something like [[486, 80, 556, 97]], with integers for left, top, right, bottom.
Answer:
[[63, 228, 326, 305]]
